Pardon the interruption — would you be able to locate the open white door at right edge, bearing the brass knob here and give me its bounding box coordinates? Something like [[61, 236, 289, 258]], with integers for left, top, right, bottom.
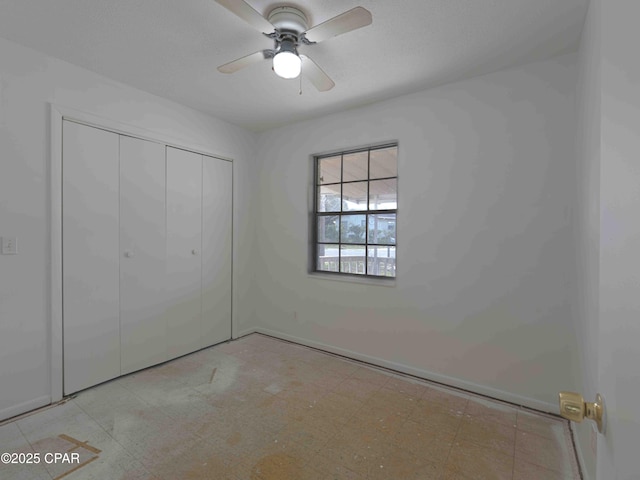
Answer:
[[592, 0, 640, 480]]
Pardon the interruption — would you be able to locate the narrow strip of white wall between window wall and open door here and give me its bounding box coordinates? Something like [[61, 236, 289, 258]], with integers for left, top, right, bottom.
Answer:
[[572, 2, 601, 479]]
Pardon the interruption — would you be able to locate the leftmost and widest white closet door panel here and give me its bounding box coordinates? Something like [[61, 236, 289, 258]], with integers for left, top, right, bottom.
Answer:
[[62, 121, 120, 394]]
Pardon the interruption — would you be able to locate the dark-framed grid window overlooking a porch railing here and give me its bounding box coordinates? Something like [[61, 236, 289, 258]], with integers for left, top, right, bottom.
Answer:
[[313, 145, 398, 277]]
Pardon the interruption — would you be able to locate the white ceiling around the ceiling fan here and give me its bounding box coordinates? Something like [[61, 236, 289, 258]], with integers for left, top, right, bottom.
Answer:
[[0, 0, 588, 131]]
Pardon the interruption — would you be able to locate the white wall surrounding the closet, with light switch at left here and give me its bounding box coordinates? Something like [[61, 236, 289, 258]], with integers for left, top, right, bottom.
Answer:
[[0, 39, 255, 419]]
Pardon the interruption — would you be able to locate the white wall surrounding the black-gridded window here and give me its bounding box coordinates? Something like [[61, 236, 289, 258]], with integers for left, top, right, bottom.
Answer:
[[252, 54, 577, 411]]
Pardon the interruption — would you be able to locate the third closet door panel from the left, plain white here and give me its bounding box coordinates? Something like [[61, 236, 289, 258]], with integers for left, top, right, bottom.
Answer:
[[165, 147, 202, 358]]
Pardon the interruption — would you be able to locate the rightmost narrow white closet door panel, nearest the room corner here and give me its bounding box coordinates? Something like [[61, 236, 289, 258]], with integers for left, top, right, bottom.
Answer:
[[202, 156, 233, 347]]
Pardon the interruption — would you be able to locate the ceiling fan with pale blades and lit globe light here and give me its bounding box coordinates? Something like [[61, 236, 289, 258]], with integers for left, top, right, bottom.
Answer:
[[216, 0, 372, 92]]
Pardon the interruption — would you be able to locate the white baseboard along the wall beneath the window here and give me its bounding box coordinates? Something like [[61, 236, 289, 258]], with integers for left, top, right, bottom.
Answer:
[[248, 327, 559, 415]]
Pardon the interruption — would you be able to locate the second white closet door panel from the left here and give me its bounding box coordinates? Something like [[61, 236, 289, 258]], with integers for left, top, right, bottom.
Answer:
[[120, 136, 167, 374]]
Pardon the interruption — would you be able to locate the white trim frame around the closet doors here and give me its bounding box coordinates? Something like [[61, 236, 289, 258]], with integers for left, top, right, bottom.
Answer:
[[49, 103, 237, 403]]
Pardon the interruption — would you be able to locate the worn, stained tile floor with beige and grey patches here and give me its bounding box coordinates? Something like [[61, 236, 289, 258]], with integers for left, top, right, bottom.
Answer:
[[0, 334, 580, 480]]
